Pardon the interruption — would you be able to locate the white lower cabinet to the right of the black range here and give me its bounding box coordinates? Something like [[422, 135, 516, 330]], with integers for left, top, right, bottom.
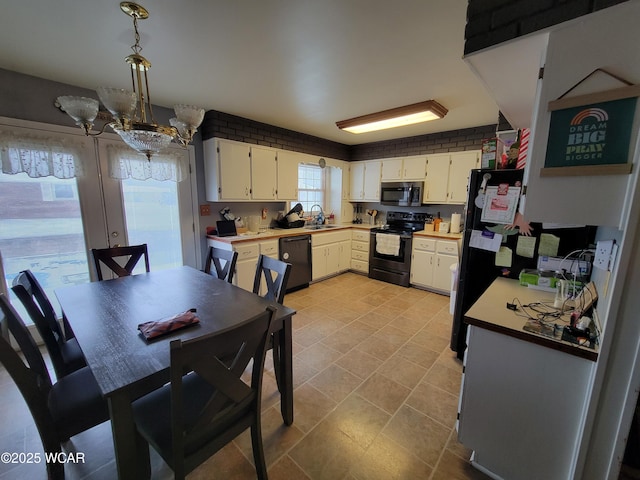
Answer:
[[411, 237, 458, 293]]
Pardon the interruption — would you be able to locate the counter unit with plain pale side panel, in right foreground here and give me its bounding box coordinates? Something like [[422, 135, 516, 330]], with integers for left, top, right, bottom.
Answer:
[[458, 278, 597, 480]]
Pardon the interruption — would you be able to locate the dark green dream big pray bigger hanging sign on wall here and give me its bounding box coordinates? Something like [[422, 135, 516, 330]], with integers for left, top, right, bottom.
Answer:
[[540, 72, 640, 176]]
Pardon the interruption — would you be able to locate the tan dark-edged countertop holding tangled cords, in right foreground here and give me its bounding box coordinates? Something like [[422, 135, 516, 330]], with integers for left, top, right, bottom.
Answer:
[[464, 278, 598, 361]]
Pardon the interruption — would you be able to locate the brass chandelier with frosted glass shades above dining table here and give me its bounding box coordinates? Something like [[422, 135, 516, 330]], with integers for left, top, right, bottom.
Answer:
[[56, 2, 204, 160]]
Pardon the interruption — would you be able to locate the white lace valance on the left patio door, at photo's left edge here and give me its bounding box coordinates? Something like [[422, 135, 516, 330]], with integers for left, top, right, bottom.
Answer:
[[0, 130, 85, 178]]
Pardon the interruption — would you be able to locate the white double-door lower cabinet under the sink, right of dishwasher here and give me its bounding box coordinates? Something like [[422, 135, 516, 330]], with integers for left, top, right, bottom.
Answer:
[[311, 230, 351, 281]]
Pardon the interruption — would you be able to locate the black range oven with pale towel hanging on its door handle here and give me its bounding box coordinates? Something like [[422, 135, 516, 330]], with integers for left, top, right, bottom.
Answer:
[[369, 212, 432, 287]]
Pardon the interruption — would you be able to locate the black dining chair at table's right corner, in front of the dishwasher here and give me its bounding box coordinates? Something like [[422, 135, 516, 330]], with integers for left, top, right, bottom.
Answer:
[[253, 255, 291, 393]]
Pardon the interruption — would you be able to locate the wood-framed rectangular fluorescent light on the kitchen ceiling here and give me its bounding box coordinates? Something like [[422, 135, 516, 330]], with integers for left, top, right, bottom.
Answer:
[[336, 100, 448, 133]]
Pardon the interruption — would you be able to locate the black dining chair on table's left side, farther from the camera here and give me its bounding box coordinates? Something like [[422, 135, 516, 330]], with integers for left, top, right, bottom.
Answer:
[[11, 270, 87, 378]]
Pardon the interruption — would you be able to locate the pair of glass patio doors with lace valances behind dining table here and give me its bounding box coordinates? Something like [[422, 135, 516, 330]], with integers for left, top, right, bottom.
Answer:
[[0, 120, 199, 323]]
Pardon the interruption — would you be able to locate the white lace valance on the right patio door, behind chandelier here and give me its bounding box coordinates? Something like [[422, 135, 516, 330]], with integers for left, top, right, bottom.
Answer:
[[107, 144, 189, 182]]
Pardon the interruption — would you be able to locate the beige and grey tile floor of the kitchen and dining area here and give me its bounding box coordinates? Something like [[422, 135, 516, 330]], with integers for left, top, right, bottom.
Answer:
[[0, 273, 488, 480]]
